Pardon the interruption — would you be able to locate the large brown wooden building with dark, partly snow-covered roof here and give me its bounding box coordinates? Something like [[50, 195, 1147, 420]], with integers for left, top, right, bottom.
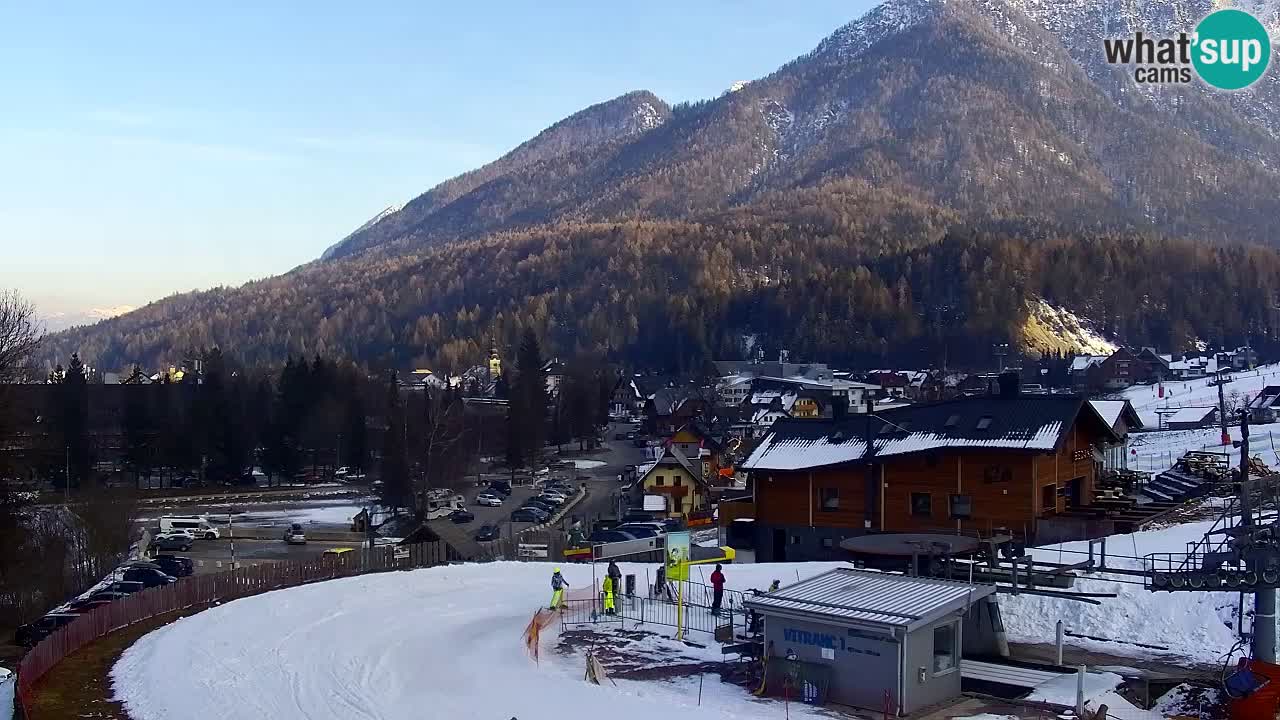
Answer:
[[740, 375, 1119, 562]]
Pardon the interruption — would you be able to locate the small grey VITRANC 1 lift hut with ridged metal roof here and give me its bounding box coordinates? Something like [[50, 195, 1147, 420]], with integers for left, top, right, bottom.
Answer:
[[745, 569, 1002, 715]]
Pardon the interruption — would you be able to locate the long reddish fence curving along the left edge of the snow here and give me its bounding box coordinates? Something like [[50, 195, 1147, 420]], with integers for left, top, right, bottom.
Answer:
[[15, 542, 452, 720]]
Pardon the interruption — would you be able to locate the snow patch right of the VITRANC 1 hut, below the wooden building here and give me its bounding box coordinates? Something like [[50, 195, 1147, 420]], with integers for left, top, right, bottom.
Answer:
[[1000, 520, 1252, 661]]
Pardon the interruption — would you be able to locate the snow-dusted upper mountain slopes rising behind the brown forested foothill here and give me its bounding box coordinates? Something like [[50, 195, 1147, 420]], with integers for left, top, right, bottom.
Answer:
[[314, 0, 1280, 256]]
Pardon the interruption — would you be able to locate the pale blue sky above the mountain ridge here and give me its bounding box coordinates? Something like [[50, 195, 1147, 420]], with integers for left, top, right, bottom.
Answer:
[[0, 0, 873, 319]]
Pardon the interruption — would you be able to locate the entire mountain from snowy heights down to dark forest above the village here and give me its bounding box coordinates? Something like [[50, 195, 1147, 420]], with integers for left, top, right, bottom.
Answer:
[[40, 0, 1280, 368]]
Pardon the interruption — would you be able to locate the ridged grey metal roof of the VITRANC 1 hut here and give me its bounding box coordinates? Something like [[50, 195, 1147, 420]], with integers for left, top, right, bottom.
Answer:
[[745, 568, 996, 630]]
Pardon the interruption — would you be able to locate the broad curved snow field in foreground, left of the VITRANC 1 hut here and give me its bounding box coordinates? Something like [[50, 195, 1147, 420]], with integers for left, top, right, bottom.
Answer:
[[111, 562, 841, 720]]
